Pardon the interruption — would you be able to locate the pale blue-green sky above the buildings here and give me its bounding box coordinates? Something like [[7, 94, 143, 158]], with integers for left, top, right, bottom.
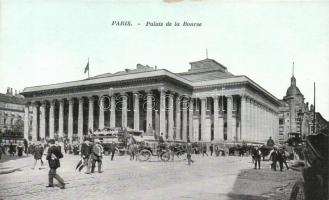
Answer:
[[0, 0, 329, 120]]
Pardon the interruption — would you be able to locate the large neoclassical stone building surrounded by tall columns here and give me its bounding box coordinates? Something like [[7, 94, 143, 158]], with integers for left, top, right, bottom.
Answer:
[[22, 59, 280, 142]]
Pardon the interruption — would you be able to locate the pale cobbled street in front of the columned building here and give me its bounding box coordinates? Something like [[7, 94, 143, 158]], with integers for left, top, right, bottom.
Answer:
[[0, 155, 299, 200]]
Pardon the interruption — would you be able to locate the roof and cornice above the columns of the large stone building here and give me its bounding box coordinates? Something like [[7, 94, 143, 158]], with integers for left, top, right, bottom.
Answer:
[[22, 58, 279, 104]]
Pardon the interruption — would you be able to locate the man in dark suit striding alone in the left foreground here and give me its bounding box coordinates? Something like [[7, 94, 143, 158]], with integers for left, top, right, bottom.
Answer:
[[46, 139, 65, 189]]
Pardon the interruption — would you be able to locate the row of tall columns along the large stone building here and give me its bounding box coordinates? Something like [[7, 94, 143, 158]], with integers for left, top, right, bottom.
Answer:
[[24, 88, 278, 142]]
